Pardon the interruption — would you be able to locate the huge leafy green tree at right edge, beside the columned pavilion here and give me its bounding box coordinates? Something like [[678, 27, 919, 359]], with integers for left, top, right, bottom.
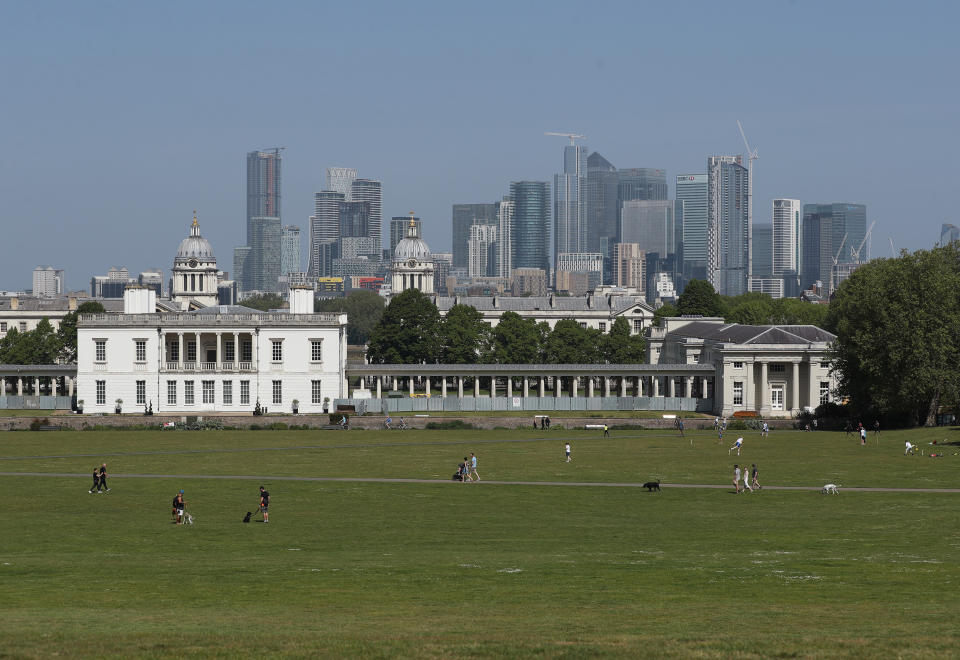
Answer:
[[827, 243, 960, 425]]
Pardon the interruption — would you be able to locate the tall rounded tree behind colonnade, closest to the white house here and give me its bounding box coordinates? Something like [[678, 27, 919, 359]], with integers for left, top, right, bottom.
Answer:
[[367, 289, 440, 364]]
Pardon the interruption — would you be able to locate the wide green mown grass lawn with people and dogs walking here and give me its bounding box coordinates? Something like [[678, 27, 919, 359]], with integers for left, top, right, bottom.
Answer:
[[0, 429, 960, 658]]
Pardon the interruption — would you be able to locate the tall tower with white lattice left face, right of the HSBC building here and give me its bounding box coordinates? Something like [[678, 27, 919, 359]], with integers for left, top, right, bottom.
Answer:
[[704, 156, 751, 296]]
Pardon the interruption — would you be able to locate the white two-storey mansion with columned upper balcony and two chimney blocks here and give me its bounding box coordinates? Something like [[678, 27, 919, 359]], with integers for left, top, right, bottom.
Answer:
[[77, 285, 347, 414]]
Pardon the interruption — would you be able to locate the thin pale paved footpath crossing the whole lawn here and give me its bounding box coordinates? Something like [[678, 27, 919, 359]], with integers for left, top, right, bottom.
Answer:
[[0, 472, 960, 493]]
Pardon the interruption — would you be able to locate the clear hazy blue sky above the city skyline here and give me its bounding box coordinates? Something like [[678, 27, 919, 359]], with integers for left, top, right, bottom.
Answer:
[[0, 0, 960, 290]]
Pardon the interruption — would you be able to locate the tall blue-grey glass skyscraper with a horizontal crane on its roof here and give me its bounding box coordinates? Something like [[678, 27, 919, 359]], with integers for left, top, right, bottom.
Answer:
[[553, 144, 587, 257]]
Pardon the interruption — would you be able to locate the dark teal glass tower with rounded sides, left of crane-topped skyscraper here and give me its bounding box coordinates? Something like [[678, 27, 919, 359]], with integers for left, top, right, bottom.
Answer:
[[510, 181, 550, 273]]
